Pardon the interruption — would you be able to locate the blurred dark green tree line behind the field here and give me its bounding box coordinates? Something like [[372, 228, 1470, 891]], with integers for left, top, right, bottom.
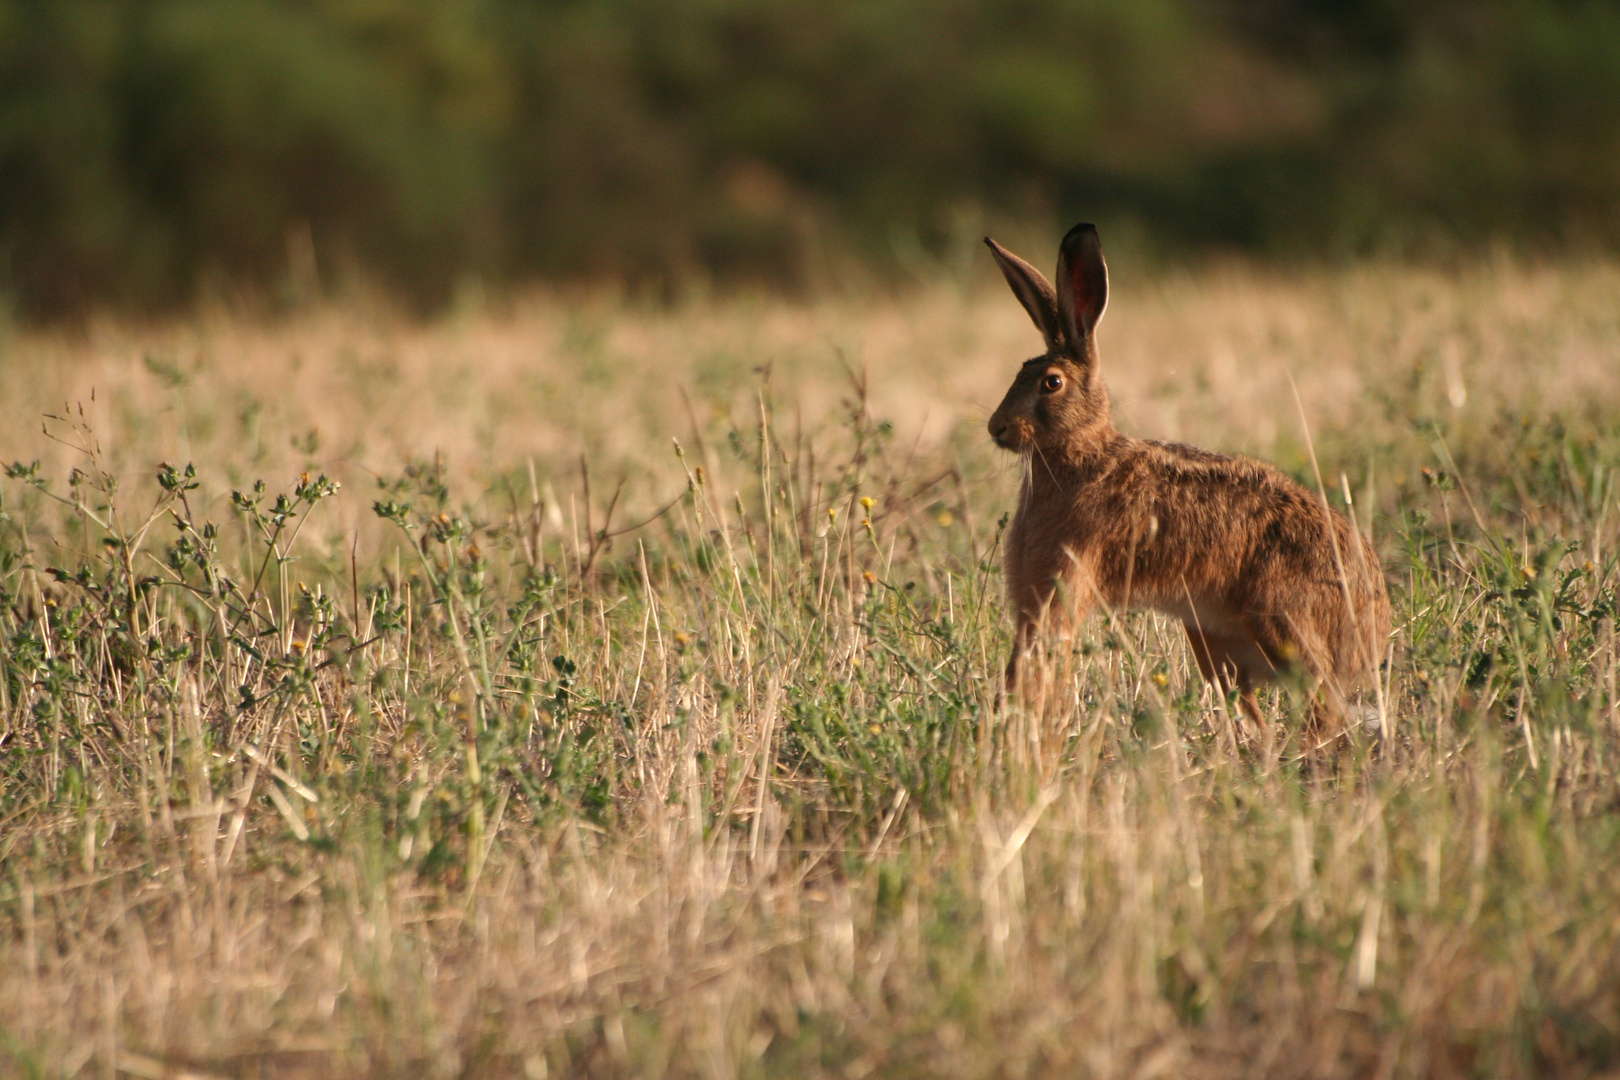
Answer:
[[0, 0, 1620, 319]]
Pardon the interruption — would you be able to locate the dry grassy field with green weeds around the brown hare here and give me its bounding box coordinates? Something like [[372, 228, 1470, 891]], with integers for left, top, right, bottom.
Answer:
[[0, 261, 1620, 1080]]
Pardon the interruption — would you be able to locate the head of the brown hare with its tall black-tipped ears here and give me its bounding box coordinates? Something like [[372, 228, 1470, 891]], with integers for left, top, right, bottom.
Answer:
[[985, 225, 1113, 458]]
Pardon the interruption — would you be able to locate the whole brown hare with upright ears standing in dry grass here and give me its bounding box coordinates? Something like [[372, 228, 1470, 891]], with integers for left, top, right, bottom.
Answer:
[[985, 225, 1390, 724]]
